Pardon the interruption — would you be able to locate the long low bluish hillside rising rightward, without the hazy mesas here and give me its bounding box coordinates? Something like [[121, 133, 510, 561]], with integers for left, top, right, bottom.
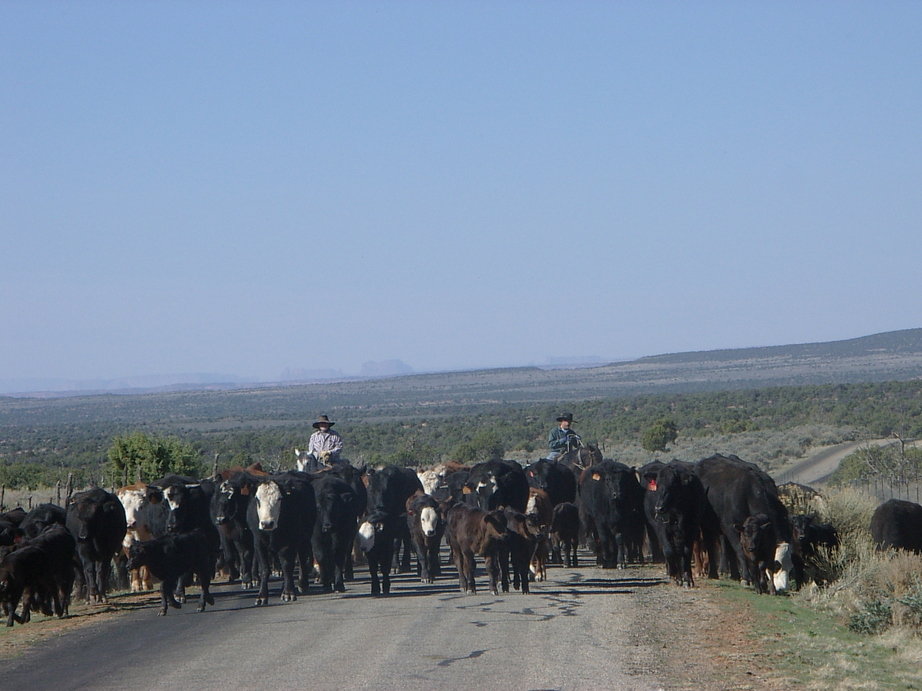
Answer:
[[0, 329, 922, 428]]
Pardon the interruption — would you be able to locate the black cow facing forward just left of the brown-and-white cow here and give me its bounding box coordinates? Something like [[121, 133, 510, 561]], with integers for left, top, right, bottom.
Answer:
[[66, 487, 128, 604]]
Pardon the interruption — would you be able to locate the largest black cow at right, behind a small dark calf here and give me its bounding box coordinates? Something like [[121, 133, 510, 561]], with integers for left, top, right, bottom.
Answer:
[[694, 454, 793, 592]]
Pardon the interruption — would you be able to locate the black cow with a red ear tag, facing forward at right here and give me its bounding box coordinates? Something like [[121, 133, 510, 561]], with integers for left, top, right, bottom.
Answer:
[[644, 461, 707, 587]]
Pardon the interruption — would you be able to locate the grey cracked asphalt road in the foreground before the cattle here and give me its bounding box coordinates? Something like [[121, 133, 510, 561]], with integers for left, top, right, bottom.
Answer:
[[0, 562, 674, 689]]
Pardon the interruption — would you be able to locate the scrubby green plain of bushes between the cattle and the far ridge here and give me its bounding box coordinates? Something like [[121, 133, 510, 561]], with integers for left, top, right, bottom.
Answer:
[[0, 381, 922, 488]]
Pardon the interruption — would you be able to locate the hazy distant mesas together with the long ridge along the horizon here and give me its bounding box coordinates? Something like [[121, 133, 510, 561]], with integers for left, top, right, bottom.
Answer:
[[7, 329, 922, 400]]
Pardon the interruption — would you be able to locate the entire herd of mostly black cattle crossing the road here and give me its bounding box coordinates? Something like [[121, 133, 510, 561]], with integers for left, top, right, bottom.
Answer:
[[0, 447, 922, 626]]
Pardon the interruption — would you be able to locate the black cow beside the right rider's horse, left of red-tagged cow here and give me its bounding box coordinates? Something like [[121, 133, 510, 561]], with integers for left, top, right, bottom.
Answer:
[[579, 459, 644, 569]]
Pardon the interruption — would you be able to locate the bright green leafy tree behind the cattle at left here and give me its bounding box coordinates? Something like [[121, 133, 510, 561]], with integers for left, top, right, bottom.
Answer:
[[106, 432, 202, 485]]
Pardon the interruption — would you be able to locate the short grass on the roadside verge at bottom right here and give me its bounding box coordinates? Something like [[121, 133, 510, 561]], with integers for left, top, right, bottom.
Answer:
[[708, 581, 922, 690]]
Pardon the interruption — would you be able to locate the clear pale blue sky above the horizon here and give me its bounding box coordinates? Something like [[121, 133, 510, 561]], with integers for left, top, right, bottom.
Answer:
[[0, 0, 922, 381]]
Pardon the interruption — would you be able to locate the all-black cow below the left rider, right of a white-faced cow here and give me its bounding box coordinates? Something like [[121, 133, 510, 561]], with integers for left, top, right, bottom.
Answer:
[[311, 473, 364, 593]]
